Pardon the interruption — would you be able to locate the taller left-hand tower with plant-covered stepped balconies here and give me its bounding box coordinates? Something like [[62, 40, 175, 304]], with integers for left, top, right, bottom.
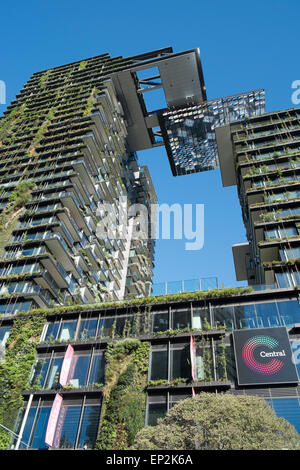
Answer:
[[0, 55, 156, 314]]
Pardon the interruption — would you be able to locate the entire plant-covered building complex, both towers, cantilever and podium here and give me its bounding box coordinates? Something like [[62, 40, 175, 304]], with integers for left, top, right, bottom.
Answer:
[[0, 48, 300, 450]]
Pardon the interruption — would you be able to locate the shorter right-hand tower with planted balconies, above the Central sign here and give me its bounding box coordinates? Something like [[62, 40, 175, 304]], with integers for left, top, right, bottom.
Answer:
[[216, 108, 300, 287]]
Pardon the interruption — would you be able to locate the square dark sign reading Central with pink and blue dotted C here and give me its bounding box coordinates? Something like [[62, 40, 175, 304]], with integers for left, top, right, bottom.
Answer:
[[233, 327, 299, 385]]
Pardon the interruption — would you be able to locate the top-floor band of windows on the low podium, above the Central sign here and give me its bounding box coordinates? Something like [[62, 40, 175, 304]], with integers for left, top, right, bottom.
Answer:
[[43, 300, 300, 342]]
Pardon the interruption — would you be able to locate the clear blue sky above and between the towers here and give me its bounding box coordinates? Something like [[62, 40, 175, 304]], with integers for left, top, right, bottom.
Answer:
[[0, 0, 300, 286]]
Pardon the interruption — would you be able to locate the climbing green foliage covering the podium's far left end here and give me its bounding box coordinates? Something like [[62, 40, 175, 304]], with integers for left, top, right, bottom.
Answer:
[[0, 316, 45, 449]]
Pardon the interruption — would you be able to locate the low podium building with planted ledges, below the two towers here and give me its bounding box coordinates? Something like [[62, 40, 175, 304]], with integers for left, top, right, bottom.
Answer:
[[0, 288, 300, 449]]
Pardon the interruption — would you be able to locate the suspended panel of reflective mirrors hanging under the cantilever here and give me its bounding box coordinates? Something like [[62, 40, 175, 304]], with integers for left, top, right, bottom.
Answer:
[[158, 89, 265, 176]]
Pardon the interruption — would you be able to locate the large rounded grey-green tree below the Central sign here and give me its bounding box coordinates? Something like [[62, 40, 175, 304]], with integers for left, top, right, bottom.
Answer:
[[132, 393, 300, 450]]
